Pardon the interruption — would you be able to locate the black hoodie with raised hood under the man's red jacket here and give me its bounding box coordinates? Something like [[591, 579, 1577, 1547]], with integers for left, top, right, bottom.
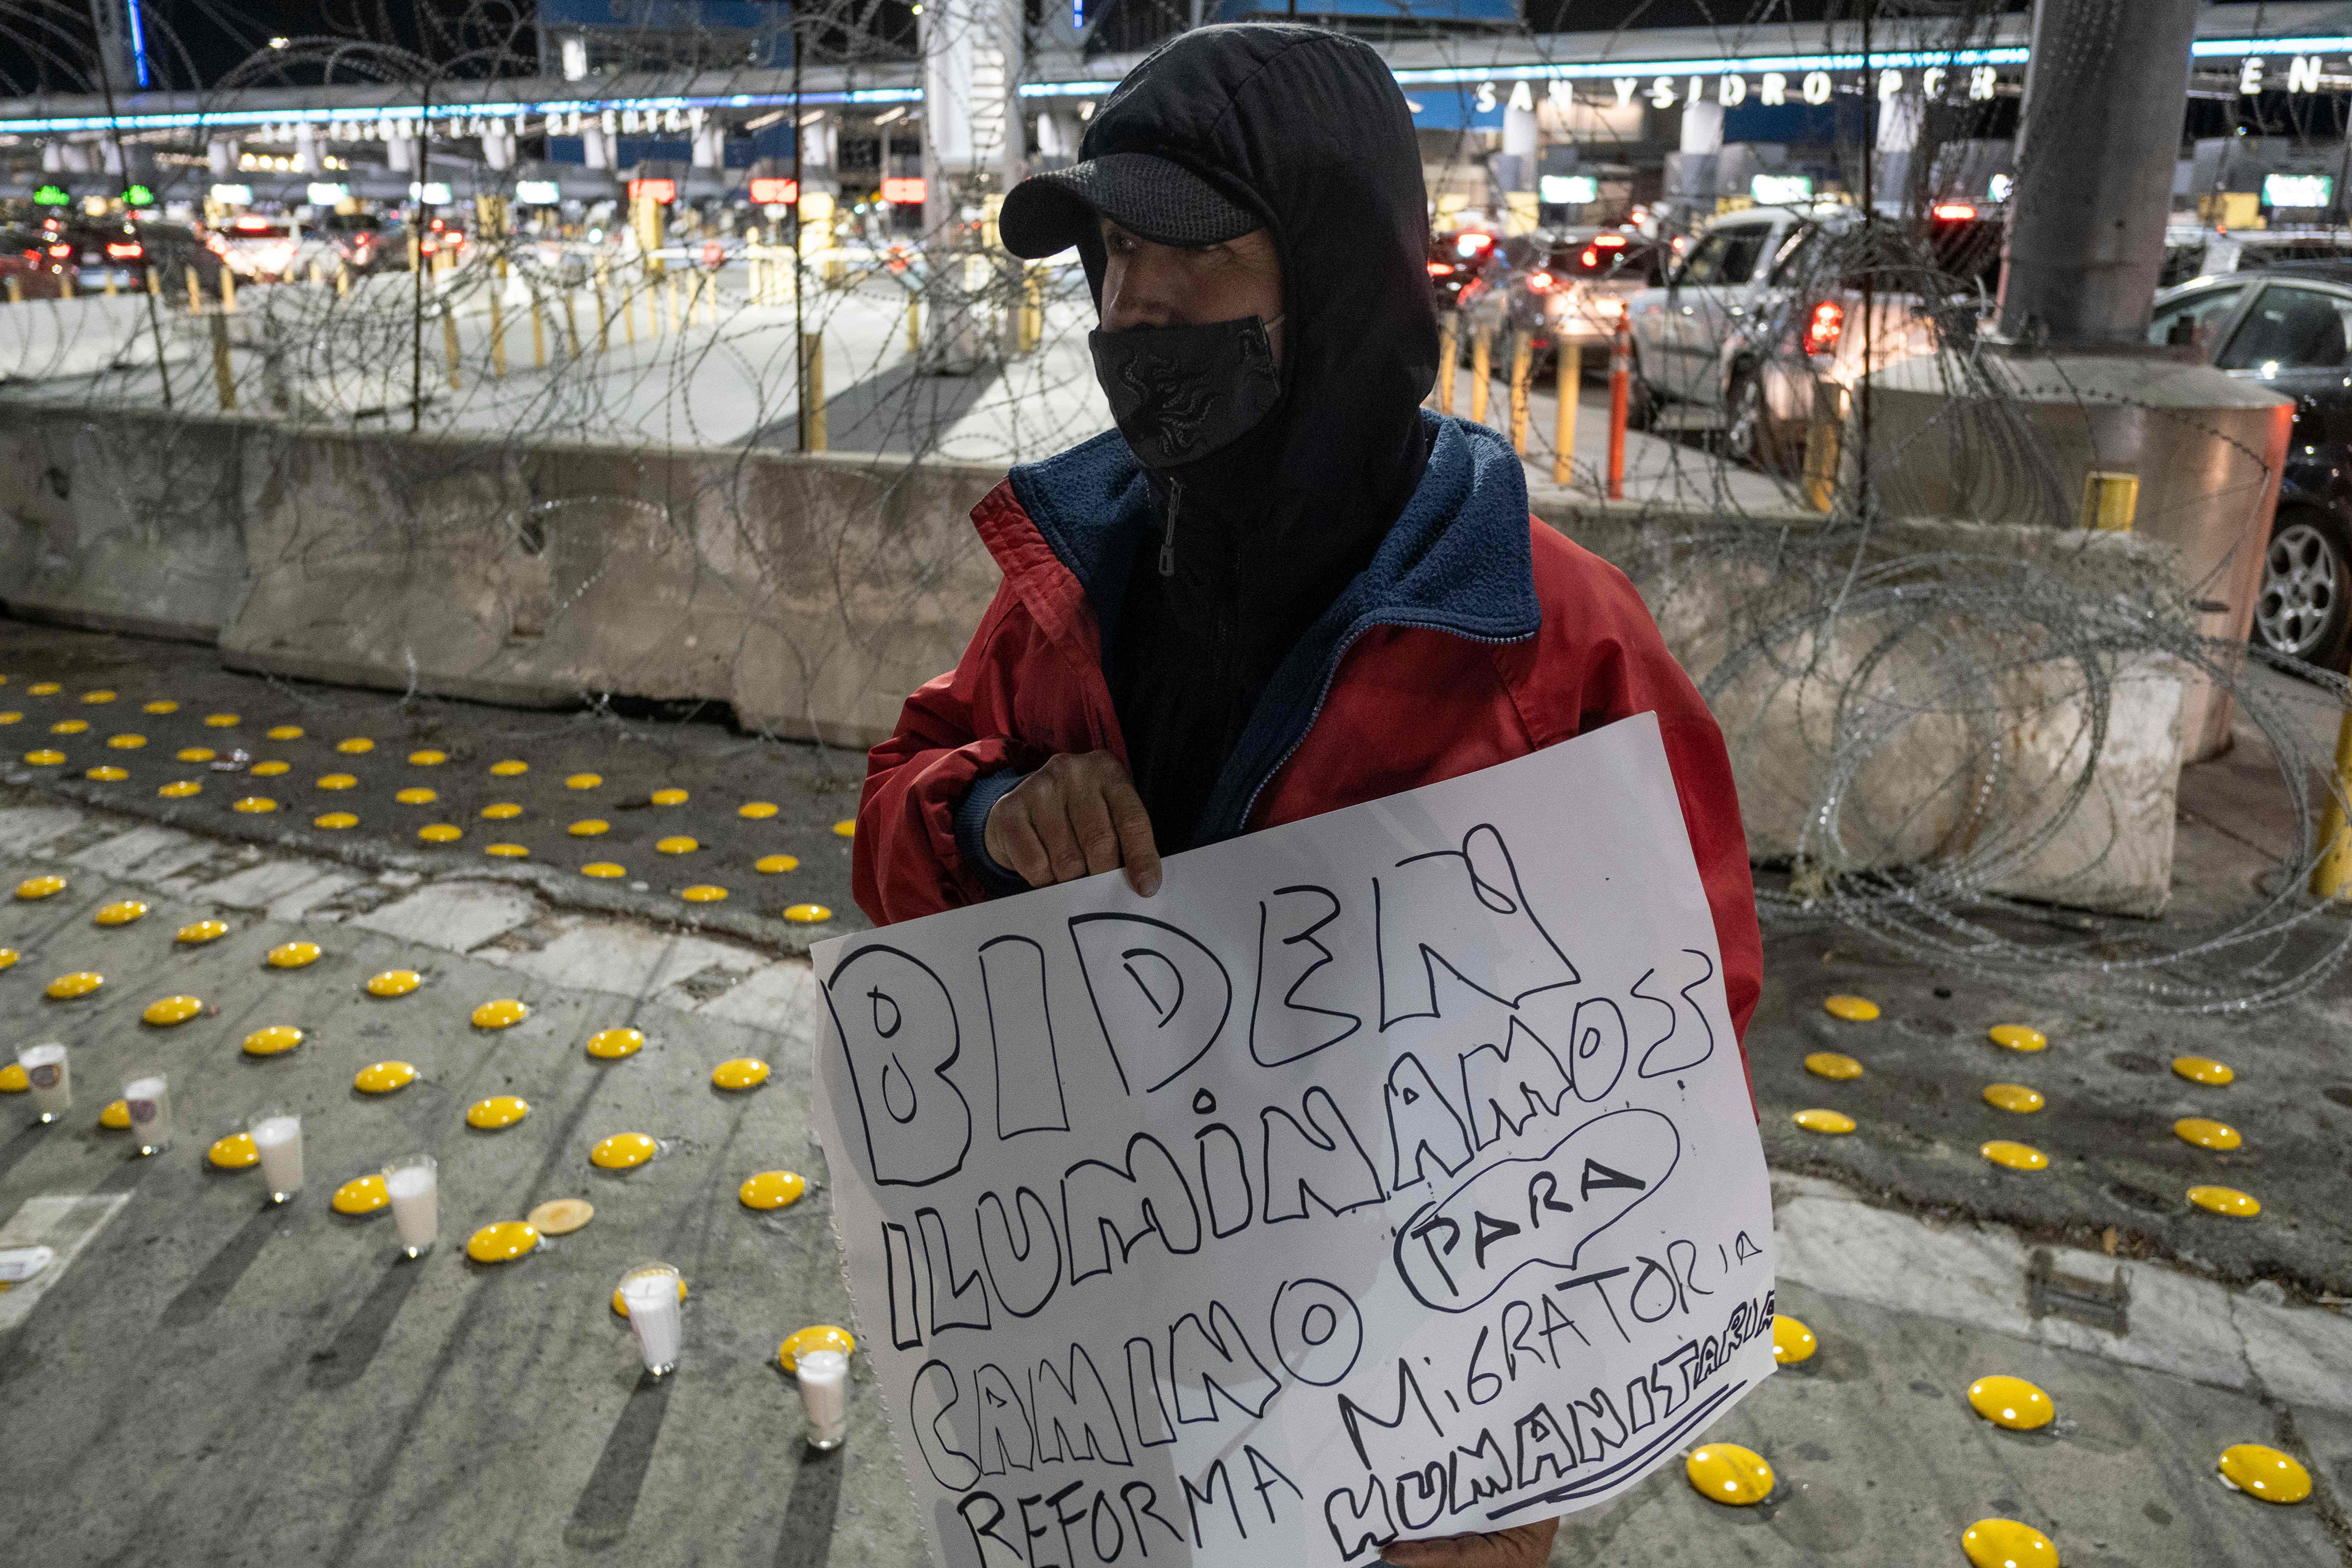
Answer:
[[1040, 23, 1437, 849]]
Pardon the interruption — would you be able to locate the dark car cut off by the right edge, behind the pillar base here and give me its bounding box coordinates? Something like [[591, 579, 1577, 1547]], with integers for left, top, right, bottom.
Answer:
[[2147, 261, 2352, 670]]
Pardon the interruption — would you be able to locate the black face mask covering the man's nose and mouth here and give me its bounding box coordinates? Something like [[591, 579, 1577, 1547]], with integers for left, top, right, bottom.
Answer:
[[1087, 315, 1282, 468]]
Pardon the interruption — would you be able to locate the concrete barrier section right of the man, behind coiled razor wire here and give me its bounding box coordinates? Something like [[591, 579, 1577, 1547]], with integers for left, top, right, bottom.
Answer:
[[1536, 494, 2194, 914]]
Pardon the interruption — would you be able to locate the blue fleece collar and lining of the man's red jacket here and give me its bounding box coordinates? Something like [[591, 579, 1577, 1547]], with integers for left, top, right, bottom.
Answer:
[[1009, 409, 1543, 849]]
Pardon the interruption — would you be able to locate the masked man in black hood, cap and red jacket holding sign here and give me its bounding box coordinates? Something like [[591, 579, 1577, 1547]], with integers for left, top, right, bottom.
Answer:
[[854, 26, 1762, 1568]]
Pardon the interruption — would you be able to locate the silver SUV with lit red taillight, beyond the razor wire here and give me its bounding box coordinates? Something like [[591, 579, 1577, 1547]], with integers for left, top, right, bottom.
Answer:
[[1625, 202, 2001, 468]]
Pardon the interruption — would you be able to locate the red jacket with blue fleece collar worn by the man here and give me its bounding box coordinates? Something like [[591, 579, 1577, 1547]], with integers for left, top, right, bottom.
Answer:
[[851, 416, 1764, 1053]]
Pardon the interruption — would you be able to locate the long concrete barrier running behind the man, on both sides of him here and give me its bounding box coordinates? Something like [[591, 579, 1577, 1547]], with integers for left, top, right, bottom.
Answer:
[[0, 409, 2180, 914]]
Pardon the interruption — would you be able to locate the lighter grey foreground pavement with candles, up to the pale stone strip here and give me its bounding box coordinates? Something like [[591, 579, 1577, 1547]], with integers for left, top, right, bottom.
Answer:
[[0, 797, 2352, 1568]]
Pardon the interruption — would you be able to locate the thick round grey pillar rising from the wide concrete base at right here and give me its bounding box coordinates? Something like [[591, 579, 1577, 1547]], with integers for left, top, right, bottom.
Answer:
[[1999, 0, 2199, 348]]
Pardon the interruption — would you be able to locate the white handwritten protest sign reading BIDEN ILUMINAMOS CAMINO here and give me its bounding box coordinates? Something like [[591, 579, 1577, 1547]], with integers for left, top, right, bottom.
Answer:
[[814, 715, 1773, 1568]]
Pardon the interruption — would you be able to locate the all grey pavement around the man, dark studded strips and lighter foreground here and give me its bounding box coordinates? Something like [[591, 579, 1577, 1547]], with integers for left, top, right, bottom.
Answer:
[[0, 623, 2352, 1568]]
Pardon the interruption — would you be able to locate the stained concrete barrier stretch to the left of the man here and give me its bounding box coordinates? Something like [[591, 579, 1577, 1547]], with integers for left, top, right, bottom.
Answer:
[[0, 409, 1002, 745]]
